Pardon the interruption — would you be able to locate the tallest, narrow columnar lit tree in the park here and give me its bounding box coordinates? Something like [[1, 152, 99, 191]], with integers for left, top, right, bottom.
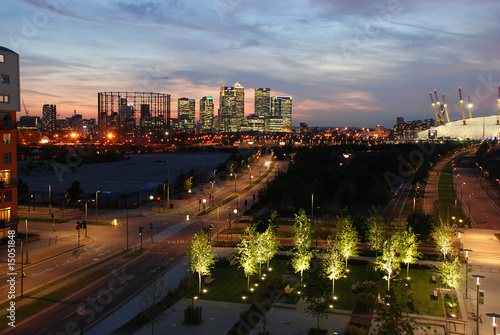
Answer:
[[292, 208, 313, 283]]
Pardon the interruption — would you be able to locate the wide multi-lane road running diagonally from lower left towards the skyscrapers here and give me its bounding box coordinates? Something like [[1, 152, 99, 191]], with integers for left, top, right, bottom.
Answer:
[[2, 158, 288, 335]]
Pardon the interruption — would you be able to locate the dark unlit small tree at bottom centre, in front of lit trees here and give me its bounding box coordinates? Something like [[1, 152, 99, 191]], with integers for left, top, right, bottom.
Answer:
[[304, 270, 329, 330]]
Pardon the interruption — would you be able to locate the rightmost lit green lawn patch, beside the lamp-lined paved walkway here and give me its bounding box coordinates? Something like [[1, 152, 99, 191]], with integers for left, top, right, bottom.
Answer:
[[380, 266, 444, 317]]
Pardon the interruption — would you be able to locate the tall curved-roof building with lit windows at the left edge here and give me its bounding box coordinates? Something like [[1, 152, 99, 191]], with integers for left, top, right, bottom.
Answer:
[[0, 46, 21, 232]]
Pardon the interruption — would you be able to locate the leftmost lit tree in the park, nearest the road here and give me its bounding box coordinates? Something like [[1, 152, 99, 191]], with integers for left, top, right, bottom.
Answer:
[[187, 230, 215, 293]]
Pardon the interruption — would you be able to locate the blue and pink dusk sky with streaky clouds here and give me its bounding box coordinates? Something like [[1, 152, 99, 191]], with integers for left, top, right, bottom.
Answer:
[[0, 0, 500, 127]]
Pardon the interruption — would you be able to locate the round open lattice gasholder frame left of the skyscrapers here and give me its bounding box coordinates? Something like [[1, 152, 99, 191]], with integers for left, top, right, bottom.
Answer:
[[97, 92, 170, 143]]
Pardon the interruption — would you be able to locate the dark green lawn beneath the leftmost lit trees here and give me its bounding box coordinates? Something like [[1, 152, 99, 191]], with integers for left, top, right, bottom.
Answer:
[[200, 259, 289, 302]]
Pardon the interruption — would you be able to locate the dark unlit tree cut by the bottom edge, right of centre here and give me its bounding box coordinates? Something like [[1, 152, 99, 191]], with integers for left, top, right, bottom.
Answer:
[[375, 283, 423, 335]]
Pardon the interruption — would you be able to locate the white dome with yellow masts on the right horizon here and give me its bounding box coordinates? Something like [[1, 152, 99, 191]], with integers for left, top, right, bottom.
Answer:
[[418, 87, 500, 140]]
